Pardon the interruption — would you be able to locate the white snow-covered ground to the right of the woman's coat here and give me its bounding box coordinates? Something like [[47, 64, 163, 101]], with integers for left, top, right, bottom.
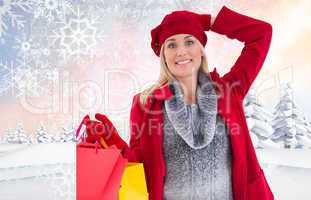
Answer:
[[257, 148, 311, 200]]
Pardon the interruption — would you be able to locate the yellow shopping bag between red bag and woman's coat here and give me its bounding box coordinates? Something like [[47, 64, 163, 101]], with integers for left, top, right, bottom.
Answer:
[[119, 163, 148, 200]]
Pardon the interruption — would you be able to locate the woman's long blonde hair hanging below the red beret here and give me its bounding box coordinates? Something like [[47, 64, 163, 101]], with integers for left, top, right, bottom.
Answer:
[[139, 39, 209, 105]]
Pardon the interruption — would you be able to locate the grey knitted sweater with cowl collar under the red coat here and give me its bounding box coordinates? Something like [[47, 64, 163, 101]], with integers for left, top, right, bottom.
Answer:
[[163, 69, 232, 200]]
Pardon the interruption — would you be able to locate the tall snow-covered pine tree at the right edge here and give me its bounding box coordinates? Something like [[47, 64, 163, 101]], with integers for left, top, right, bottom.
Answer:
[[272, 83, 311, 148]]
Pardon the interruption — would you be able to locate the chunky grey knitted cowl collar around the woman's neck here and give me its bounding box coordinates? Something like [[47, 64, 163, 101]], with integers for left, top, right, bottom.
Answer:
[[164, 71, 217, 149]]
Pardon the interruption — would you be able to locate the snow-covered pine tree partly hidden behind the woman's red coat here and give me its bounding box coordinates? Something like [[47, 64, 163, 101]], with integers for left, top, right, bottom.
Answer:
[[244, 88, 278, 148]]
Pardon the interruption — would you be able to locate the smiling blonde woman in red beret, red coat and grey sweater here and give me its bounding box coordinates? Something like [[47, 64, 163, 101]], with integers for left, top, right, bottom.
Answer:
[[95, 6, 274, 200]]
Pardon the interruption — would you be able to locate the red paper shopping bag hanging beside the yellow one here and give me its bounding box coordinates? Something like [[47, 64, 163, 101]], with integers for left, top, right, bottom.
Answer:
[[76, 115, 127, 200]]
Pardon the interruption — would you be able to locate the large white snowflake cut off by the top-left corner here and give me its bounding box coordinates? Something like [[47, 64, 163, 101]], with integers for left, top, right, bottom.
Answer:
[[0, 0, 34, 37]]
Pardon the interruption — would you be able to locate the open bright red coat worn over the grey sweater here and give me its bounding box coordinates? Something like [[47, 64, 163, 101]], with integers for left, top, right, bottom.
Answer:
[[109, 6, 274, 200]]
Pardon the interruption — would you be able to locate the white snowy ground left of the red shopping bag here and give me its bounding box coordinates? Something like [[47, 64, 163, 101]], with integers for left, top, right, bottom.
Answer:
[[0, 143, 76, 200]]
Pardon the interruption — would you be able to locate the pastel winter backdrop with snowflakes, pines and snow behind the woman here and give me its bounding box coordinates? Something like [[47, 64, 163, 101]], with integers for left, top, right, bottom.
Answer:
[[0, 0, 311, 200]]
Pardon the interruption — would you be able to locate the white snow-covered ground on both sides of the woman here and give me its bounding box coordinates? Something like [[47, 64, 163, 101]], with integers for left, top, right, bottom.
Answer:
[[0, 143, 311, 200]]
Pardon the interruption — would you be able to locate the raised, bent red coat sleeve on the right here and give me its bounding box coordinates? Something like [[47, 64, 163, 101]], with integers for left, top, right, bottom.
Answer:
[[211, 6, 272, 99]]
